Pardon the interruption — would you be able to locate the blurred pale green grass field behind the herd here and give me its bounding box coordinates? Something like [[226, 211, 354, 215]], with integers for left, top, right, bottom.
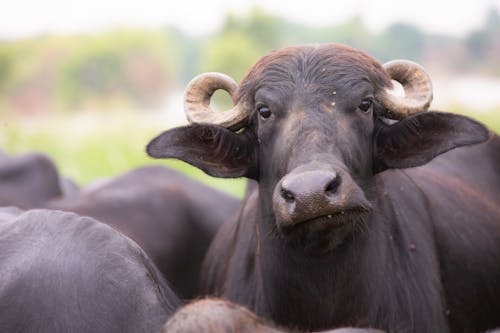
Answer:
[[0, 110, 500, 197]]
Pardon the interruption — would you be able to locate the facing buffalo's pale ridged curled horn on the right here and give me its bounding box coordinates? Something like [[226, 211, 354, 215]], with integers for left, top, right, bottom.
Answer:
[[380, 60, 432, 119]]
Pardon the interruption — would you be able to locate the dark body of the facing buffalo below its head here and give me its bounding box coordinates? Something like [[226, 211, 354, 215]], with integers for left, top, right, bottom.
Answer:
[[199, 137, 500, 332]]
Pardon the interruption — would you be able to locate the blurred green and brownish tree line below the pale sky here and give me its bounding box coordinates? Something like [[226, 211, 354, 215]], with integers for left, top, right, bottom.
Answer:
[[0, 8, 500, 114]]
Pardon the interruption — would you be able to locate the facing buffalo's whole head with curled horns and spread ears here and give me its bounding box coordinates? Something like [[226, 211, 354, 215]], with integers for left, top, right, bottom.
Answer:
[[147, 44, 487, 254]]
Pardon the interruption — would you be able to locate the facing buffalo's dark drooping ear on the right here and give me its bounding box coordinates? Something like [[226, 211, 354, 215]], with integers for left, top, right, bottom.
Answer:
[[374, 112, 489, 172]]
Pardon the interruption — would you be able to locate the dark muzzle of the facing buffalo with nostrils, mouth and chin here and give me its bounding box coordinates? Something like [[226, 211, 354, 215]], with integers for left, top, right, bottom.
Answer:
[[273, 163, 371, 253]]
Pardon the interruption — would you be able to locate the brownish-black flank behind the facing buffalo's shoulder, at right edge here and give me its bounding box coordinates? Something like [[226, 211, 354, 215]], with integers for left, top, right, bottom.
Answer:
[[405, 135, 500, 332]]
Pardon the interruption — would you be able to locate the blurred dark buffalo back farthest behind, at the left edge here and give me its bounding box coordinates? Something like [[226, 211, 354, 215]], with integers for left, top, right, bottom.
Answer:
[[0, 151, 76, 208]]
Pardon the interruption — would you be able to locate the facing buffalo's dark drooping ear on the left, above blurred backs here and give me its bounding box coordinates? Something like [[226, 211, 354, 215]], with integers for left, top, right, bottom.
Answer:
[[146, 124, 257, 179]]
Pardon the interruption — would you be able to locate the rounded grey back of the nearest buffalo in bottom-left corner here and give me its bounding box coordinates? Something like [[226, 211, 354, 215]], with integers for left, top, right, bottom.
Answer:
[[0, 208, 180, 333]]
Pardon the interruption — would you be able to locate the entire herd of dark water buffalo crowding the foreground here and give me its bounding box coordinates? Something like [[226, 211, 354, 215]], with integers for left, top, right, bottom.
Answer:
[[0, 44, 500, 333]]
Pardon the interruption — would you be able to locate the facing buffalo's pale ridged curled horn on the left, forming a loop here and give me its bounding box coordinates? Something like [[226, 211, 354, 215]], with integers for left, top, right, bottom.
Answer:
[[184, 72, 250, 131]]
